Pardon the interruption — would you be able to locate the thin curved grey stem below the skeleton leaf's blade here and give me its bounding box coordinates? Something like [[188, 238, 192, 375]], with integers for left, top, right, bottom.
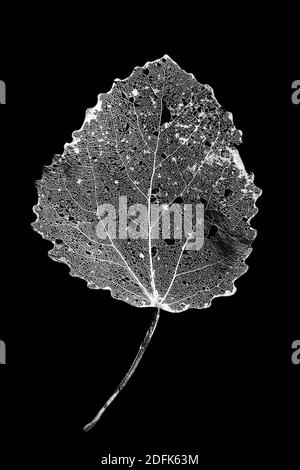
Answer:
[[83, 307, 160, 431]]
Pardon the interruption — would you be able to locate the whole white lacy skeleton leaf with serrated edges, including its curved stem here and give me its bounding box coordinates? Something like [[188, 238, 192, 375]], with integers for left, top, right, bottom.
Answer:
[[32, 55, 262, 431]]
